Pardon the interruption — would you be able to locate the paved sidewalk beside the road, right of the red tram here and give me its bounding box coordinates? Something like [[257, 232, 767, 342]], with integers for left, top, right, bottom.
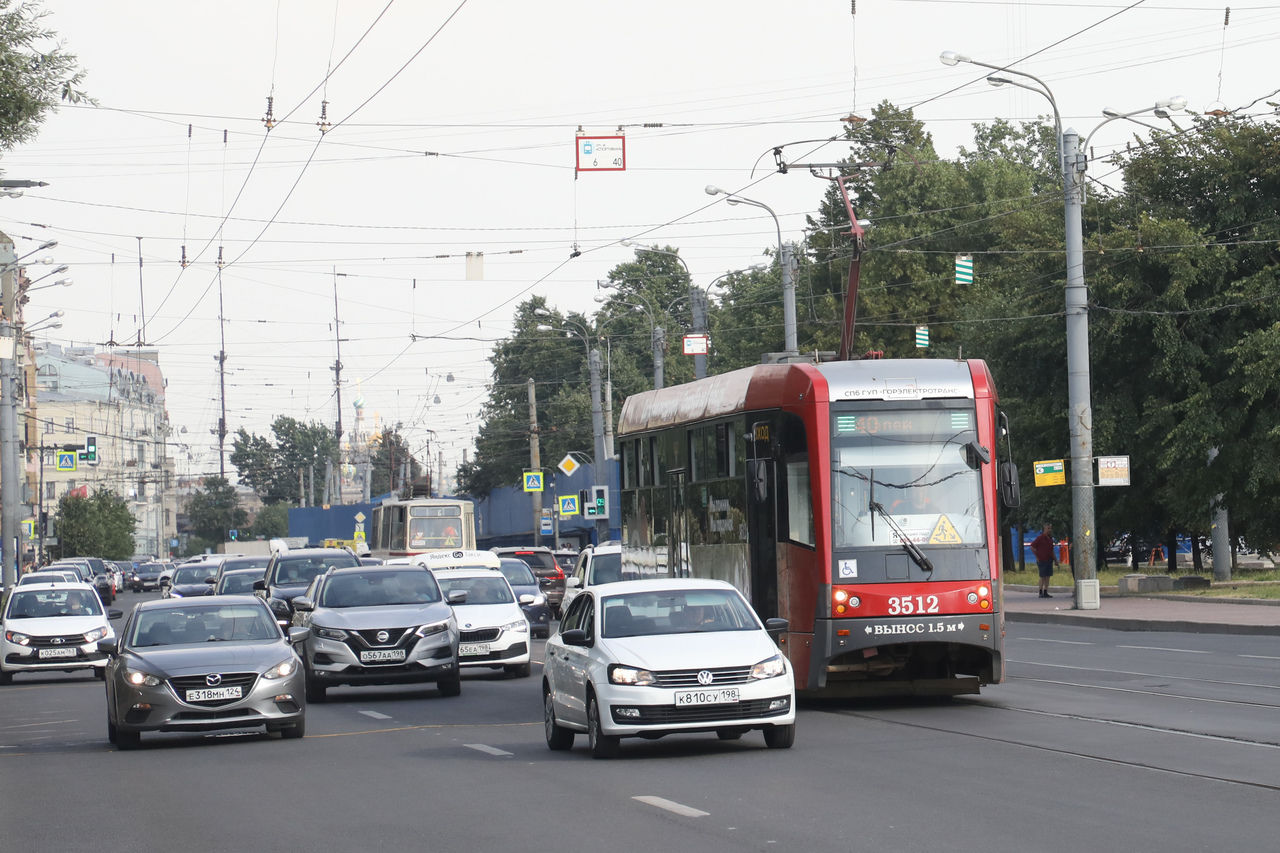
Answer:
[[1005, 584, 1280, 637]]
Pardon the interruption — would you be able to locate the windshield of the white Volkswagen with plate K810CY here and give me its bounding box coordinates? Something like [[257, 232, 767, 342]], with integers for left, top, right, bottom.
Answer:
[[602, 589, 760, 638]]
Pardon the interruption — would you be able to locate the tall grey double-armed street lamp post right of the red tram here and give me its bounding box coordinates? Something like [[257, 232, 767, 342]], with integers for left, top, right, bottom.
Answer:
[[938, 50, 1185, 610]]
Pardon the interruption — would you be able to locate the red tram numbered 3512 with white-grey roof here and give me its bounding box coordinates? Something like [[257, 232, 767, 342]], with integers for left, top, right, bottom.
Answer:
[[617, 359, 1018, 694]]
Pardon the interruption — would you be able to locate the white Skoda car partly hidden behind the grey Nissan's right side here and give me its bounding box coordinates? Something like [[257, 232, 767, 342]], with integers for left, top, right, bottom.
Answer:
[[431, 569, 534, 678]]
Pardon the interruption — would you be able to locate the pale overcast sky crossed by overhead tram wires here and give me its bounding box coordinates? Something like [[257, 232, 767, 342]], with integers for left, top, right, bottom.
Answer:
[[0, 0, 1280, 484]]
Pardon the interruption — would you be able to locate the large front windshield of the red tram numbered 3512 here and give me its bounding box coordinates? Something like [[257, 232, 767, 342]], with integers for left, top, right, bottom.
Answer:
[[831, 406, 984, 547]]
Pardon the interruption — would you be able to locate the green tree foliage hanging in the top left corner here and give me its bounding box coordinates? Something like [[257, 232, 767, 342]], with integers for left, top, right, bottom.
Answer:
[[0, 0, 93, 150]]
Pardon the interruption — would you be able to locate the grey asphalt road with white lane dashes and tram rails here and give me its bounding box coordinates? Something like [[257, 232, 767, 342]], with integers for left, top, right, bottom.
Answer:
[[0, 594, 1280, 853]]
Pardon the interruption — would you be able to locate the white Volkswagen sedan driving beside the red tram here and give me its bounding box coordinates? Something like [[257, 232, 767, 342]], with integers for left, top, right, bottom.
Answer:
[[543, 578, 795, 758]]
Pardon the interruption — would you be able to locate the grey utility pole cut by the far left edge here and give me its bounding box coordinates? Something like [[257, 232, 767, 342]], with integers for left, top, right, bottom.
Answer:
[[0, 233, 18, 589]]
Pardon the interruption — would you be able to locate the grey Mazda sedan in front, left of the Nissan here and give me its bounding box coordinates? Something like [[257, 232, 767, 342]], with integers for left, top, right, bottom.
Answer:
[[99, 596, 310, 749]]
